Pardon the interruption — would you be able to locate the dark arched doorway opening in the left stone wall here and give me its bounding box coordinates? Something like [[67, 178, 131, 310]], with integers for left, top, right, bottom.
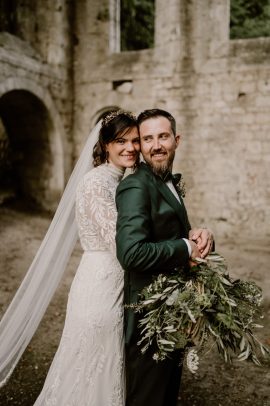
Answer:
[[0, 90, 52, 210]]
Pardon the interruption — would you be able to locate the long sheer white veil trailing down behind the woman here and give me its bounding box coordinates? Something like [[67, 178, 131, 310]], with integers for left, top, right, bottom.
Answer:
[[0, 123, 100, 387]]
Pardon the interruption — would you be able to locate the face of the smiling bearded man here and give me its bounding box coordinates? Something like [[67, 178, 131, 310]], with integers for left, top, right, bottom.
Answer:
[[139, 116, 180, 175]]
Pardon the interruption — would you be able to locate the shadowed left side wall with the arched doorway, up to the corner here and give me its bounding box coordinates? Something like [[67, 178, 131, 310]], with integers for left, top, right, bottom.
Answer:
[[0, 0, 73, 209]]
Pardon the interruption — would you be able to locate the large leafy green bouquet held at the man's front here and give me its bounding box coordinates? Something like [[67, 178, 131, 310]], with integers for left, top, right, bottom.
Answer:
[[132, 253, 270, 372]]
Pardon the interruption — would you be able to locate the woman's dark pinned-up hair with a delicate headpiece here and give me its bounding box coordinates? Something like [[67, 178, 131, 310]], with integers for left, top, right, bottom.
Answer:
[[93, 110, 138, 166]]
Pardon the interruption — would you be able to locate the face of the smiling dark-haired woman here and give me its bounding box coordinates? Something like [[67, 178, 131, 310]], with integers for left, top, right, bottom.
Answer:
[[106, 127, 140, 169]]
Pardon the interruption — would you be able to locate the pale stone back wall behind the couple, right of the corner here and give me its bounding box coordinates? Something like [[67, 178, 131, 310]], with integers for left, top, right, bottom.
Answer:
[[74, 0, 270, 241]]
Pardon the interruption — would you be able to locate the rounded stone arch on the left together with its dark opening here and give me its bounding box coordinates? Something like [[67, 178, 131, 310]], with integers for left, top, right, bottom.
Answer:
[[0, 78, 65, 209]]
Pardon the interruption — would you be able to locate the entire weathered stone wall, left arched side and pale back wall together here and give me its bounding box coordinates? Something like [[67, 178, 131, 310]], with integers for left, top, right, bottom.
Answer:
[[0, 0, 270, 242]]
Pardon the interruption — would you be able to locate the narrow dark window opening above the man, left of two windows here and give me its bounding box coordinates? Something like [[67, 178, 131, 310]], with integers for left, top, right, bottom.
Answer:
[[120, 0, 155, 51]]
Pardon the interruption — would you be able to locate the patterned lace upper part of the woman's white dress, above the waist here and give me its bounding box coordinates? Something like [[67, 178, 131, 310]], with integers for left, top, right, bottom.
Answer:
[[76, 170, 117, 254]]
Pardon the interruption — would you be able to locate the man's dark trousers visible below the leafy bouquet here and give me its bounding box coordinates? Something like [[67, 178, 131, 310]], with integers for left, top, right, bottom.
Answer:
[[126, 338, 183, 406]]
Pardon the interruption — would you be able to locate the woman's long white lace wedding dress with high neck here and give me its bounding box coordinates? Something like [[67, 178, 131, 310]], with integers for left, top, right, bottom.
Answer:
[[35, 164, 125, 406]]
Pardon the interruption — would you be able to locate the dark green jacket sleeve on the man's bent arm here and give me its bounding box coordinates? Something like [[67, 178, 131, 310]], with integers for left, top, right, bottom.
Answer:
[[116, 176, 189, 272]]
